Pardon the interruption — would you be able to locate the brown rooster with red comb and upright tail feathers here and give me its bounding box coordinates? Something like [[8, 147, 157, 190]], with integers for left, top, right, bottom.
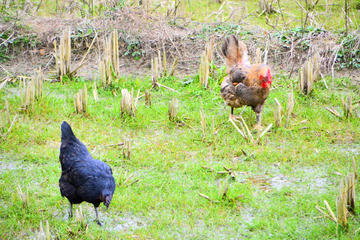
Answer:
[[221, 35, 272, 129]]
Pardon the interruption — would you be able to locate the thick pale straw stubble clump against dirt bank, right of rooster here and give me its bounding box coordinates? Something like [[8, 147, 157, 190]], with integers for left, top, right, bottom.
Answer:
[[299, 53, 321, 94]]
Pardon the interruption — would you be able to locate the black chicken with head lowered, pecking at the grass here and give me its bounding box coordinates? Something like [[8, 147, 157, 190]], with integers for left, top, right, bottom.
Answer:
[[59, 121, 115, 225]]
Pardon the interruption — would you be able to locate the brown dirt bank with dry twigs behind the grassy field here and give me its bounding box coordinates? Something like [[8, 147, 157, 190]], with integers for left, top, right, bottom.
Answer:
[[0, 7, 360, 80]]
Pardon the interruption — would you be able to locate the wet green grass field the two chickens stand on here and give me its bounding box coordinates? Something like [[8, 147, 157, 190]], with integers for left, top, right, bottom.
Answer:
[[0, 71, 360, 239]]
